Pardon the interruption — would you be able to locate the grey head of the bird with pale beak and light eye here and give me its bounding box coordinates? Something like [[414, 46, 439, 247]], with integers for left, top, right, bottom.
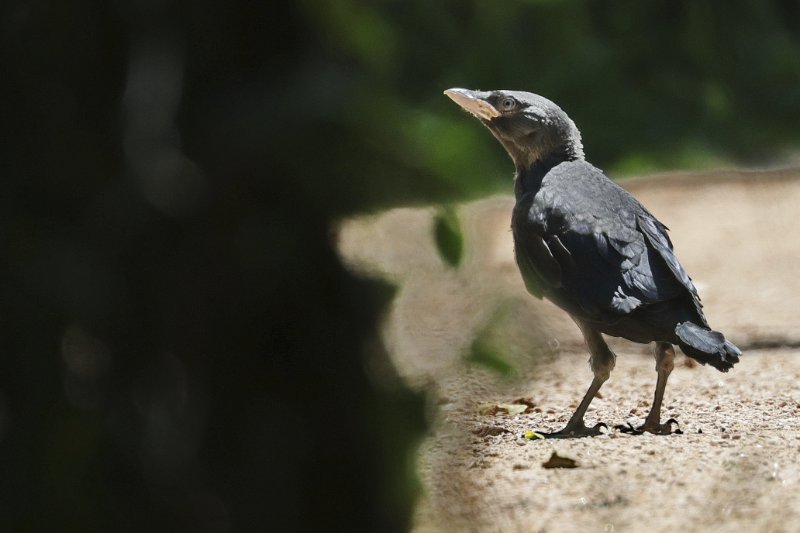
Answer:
[[444, 89, 583, 170]]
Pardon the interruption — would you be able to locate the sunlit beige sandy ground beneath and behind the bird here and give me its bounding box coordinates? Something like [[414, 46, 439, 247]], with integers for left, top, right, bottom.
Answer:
[[339, 167, 800, 533]]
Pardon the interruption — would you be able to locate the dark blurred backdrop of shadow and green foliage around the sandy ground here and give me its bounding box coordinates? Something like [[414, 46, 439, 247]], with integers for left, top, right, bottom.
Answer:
[[0, 0, 800, 532]]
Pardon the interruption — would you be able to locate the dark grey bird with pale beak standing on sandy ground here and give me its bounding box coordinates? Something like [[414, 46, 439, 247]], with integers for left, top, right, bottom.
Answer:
[[444, 88, 742, 438]]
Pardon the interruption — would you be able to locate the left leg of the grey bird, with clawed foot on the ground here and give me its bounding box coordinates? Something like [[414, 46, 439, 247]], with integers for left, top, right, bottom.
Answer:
[[542, 323, 616, 439]]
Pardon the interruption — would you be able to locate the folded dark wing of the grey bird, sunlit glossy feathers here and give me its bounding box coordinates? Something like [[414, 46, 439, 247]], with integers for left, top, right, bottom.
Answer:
[[515, 162, 697, 320]]
